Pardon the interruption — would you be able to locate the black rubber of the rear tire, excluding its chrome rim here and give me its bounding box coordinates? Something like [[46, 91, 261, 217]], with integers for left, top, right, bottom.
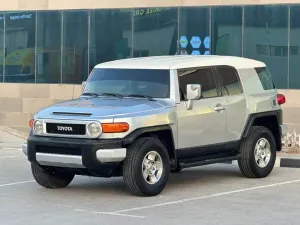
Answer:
[[238, 126, 276, 178]]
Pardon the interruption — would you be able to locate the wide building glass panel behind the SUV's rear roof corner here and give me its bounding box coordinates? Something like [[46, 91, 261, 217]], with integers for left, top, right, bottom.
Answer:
[[244, 5, 288, 88]]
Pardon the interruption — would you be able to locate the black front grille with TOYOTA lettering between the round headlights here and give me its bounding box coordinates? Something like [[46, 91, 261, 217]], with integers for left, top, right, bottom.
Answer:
[[46, 123, 86, 135]]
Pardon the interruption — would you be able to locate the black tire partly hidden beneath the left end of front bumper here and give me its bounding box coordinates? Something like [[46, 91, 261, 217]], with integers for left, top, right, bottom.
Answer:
[[31, 162, 75, 189]]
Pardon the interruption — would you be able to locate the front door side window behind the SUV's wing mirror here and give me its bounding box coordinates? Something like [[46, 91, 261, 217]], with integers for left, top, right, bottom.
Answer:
[[178, 68, 218, 100]]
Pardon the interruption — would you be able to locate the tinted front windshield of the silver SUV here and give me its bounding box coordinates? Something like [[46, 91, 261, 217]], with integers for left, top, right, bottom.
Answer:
[[83, 68, 170, 98]]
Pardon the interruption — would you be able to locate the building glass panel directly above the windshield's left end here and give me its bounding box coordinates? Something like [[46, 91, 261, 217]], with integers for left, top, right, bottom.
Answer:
[[89, 9, 132, 75]]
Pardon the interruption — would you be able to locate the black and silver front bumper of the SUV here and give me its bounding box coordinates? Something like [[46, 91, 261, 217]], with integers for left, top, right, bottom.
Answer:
[[22, 136, 126, 170]]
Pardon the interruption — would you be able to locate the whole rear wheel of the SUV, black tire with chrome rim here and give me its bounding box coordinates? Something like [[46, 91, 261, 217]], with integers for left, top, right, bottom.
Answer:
[[238, 126, 276, 178]]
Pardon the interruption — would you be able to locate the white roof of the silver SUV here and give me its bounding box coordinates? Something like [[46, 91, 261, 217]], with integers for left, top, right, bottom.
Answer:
[[95, 55, 266, 70]]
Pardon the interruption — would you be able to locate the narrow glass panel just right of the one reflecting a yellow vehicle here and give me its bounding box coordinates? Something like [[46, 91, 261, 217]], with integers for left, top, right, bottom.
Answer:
[[36, 11, 62, 83]]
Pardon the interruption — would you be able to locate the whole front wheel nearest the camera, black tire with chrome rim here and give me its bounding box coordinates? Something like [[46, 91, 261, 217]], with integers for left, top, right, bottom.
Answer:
[[123, 137, 170, 196]]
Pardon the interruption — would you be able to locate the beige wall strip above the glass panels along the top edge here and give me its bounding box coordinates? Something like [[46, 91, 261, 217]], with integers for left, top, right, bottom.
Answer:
[[0, 0, 300, 11]]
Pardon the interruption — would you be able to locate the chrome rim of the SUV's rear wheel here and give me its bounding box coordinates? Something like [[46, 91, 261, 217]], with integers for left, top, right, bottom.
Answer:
[[254, 138, 272, 168]]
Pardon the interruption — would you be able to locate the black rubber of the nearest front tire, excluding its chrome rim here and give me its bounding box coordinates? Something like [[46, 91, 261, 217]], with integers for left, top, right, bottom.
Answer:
[[123, 137, 170, 196]]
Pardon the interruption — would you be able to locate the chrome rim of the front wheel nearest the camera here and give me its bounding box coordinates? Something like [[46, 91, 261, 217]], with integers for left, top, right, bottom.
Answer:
[[142, 151, 163, 185]]
